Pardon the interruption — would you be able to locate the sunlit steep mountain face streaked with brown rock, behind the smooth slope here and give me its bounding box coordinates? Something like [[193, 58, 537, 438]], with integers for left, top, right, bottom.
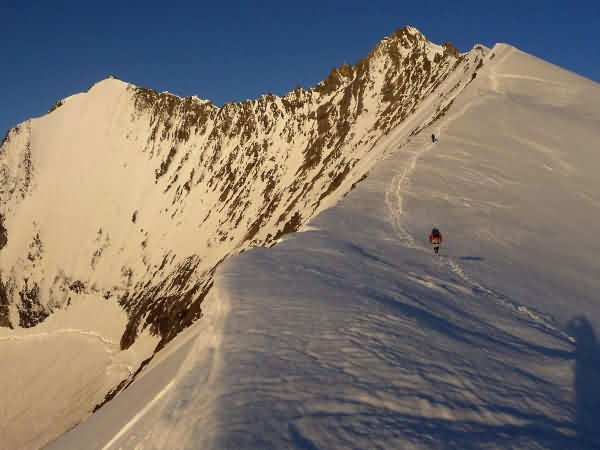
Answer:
[[0, 27, 484, 448]]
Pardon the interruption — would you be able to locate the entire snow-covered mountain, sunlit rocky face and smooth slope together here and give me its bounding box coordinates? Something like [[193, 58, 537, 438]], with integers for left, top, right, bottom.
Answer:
[[0, 27, 600, 448]]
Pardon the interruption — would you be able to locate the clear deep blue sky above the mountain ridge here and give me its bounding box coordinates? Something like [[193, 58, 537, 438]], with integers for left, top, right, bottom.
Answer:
[[0, 0, 600, 135]]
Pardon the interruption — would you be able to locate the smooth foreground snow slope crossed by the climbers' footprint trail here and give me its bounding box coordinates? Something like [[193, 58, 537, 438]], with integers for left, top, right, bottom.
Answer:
[[50, 45, 600, 449]]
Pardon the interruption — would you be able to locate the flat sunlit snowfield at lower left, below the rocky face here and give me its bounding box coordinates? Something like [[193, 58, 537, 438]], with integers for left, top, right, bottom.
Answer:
[[0, 296, 158, 449]]
